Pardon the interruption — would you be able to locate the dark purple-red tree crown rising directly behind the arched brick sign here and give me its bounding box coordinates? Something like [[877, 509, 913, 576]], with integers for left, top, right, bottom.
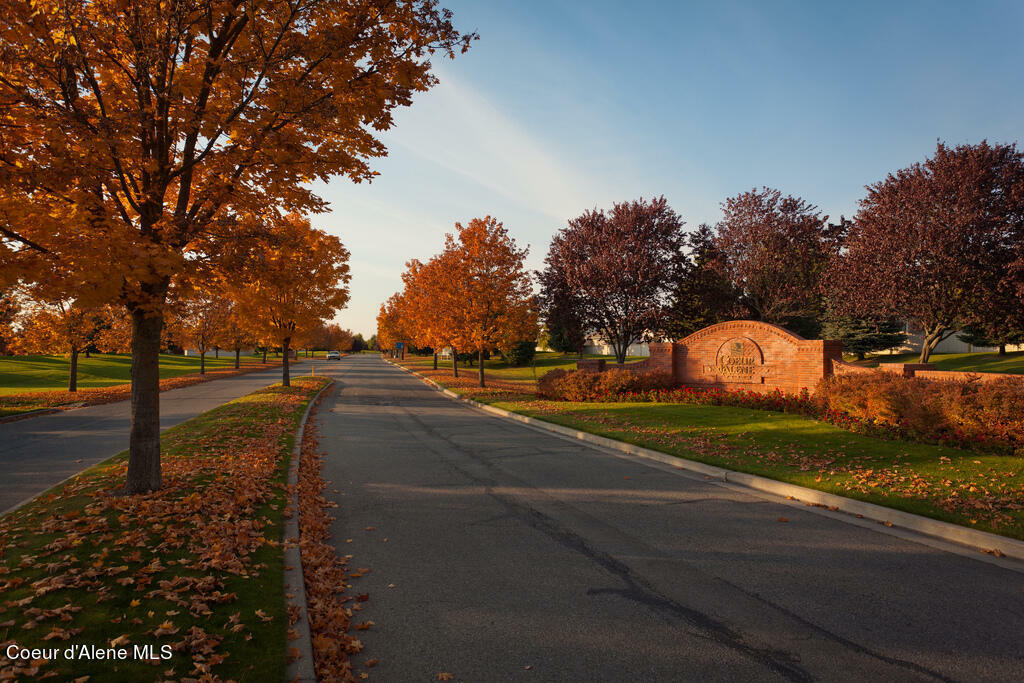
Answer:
[[715, 187, 845, 326]]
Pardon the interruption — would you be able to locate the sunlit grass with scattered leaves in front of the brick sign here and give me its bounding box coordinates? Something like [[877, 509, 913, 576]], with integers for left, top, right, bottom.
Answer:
[[393, 359, 1024, 540]]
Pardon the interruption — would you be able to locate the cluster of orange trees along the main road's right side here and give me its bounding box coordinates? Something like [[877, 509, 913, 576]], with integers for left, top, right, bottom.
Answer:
[[377, 216, 538, 387]]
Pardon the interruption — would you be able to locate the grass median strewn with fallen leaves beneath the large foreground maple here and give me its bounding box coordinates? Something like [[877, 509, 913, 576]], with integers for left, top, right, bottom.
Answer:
[[0, 377, 328, 681]]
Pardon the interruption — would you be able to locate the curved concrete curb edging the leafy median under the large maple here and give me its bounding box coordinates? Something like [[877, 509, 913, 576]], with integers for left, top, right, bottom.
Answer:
[[284, 380, 334, 683]]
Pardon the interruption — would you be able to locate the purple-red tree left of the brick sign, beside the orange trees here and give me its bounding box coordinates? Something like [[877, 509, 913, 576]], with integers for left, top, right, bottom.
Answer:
[[545, 197, 686, 365]]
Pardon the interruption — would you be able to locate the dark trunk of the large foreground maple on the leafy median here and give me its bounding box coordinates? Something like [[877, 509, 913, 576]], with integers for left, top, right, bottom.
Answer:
[[125, 308, 164, 494]]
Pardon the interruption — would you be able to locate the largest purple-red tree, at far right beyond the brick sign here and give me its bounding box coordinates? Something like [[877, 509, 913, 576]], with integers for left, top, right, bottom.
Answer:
[[827, 141, 1024, 362]]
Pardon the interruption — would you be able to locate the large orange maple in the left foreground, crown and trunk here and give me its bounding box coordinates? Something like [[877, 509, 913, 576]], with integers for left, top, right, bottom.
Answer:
[[0, 0, 475, 494]]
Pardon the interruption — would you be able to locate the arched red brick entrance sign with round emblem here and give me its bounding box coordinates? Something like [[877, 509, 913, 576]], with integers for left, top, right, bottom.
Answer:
[[647, 321, 843, 392]]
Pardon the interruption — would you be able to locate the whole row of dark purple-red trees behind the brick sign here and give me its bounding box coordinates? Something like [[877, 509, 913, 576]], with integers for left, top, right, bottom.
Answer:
[[538, 141, 1024, 362]]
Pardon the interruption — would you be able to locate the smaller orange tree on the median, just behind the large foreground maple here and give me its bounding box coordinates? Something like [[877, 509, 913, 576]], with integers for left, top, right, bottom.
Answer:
[[233, 214, 350, 386]]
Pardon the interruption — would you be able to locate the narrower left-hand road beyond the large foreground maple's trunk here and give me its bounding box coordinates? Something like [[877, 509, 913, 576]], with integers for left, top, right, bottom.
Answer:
[[0, 365, 299, 512]]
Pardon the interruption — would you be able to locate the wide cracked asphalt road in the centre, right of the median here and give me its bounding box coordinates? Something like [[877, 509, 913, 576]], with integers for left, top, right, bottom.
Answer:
[[317, 355, 1024, 681]]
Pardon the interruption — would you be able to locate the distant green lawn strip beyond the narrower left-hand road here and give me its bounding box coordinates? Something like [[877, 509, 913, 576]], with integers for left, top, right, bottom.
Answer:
[[0, 351, 275, 395]]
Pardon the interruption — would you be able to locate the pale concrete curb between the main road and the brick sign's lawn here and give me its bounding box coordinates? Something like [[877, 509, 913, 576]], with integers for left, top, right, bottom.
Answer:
[[384, 358, 1024, 570]]
